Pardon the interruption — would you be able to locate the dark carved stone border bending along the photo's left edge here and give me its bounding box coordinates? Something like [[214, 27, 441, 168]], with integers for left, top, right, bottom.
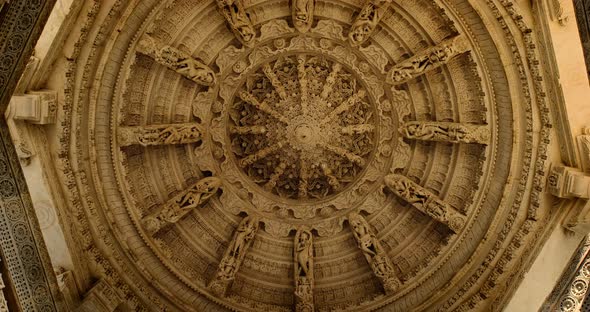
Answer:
[[0, 0, 63, 311]]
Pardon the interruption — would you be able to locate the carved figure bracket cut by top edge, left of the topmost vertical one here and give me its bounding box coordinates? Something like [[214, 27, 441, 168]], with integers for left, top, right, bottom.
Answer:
[[217, 0, 256, 45]]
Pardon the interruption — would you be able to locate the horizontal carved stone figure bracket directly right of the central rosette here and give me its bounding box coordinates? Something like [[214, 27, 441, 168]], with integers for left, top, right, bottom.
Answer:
[[400, 121, 490, 144]]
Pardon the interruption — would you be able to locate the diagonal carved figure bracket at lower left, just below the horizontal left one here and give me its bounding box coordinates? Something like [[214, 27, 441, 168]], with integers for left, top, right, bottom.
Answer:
[[143, 177, 221, 235]]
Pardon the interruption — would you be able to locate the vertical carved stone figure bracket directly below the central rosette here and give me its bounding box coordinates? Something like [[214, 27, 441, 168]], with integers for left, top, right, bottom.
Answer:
[[294, 229, 314, 312]]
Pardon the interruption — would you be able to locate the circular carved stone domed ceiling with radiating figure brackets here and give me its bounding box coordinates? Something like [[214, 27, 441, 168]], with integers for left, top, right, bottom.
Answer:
[[55, 0, 548, 311]]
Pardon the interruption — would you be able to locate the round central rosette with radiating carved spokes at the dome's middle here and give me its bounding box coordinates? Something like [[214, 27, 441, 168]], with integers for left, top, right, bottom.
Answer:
[[229, 54, 377, 199]]
